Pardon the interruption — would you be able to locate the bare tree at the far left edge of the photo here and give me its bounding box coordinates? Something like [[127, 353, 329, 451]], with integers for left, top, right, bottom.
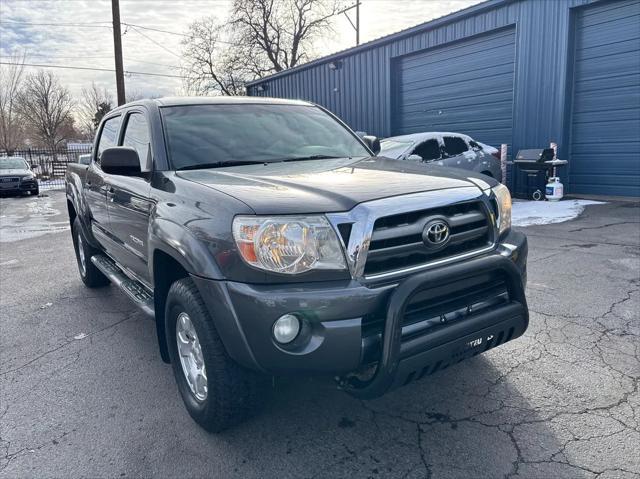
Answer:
[[0, 53, 25, 152]]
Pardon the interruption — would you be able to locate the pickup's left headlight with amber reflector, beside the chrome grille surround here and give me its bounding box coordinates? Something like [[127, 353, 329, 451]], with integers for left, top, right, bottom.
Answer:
[[233, 216, 346, 274]]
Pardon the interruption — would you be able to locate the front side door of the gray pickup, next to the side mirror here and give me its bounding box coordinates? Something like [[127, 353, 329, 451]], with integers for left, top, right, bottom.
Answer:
[[107, 110, 152, 285]]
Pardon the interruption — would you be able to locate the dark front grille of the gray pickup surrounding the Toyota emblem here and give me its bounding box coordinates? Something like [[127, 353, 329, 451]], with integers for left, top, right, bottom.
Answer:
[[364, 201, 493, 276]]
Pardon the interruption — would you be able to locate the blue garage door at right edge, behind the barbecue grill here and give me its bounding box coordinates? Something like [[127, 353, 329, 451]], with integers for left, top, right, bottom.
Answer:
[[569, 0, 640, 196]]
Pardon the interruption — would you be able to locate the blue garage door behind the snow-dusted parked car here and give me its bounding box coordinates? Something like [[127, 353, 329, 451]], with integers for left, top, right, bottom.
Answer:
[[392, 28, 515, 145]]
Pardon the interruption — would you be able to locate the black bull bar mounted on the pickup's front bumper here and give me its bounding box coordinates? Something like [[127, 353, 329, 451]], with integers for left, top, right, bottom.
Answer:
[[342, 254, 529, 399]]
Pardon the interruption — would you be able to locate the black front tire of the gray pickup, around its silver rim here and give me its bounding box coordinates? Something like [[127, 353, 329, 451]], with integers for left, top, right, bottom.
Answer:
[[165, 278, 267, 432]]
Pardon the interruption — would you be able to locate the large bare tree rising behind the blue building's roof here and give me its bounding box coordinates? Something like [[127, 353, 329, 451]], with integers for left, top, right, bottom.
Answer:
[[231, 0, 343, 77]]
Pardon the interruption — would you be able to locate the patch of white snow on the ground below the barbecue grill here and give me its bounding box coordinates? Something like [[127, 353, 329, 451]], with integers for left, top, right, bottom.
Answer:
[[511, 200, 604, 226]]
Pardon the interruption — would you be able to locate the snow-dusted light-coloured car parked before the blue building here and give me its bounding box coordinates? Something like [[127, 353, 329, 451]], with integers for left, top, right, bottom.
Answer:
[[378, 132, 502, 181]]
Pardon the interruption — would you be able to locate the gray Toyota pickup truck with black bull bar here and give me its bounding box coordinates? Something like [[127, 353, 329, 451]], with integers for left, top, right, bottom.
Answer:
[[66, 97, 528, 431]]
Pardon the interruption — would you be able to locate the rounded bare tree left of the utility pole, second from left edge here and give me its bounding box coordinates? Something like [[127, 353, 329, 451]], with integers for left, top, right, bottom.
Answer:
[[19, 70, 73, 149]]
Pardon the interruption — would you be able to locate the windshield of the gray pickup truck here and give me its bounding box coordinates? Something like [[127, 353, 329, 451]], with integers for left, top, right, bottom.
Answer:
[[161, 104, 371, 170]]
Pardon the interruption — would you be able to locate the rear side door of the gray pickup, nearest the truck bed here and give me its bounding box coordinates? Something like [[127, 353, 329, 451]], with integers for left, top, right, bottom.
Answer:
[[84, 115, 122, 246]]
